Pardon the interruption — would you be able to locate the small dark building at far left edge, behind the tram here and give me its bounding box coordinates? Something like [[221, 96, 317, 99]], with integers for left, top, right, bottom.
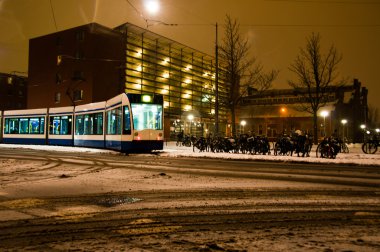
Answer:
[[0, 73, 27, 111]]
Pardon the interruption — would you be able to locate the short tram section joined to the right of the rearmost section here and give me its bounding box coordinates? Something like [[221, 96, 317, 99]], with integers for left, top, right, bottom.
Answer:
[[47, 106, 74, 146]]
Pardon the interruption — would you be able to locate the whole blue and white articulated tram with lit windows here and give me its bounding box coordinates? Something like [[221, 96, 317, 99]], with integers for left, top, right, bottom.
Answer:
[[0, 93, 164, 153]]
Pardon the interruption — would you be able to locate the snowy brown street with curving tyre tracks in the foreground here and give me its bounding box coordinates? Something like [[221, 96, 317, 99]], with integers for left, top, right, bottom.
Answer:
[[0, 148, 380, 251]]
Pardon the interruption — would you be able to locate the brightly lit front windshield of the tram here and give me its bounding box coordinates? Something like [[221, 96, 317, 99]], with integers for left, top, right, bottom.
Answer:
[[131, 103, 163, 130]]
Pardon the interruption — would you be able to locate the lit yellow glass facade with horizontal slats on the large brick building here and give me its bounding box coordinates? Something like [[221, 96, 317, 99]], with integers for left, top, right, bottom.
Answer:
[[116, 24, 228, 137]]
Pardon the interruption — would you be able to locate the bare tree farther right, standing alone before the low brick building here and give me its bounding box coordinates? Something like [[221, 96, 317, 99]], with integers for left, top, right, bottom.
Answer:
[[289, 33, 342, 143]]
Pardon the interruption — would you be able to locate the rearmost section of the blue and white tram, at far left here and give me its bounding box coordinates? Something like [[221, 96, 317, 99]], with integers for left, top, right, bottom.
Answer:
[[3, 108, 47, 145]]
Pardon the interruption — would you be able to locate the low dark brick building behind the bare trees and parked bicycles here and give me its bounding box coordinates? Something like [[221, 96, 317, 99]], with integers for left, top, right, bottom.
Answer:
[[238, 79, 368, 142]]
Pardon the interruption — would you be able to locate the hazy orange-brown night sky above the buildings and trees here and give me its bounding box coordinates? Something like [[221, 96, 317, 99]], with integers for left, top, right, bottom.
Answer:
[[0, 0, 380, 109]]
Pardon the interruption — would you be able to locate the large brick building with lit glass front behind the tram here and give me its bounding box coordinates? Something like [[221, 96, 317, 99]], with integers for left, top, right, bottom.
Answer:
[[28, 23, 228, 138]]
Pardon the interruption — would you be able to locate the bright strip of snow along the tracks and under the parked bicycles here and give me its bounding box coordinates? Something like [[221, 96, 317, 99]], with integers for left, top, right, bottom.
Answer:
[[0, 142, 380, 166]]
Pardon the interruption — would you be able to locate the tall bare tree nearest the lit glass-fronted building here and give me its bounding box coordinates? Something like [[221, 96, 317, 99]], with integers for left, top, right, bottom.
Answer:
[[220, 15, 278, 135]]
